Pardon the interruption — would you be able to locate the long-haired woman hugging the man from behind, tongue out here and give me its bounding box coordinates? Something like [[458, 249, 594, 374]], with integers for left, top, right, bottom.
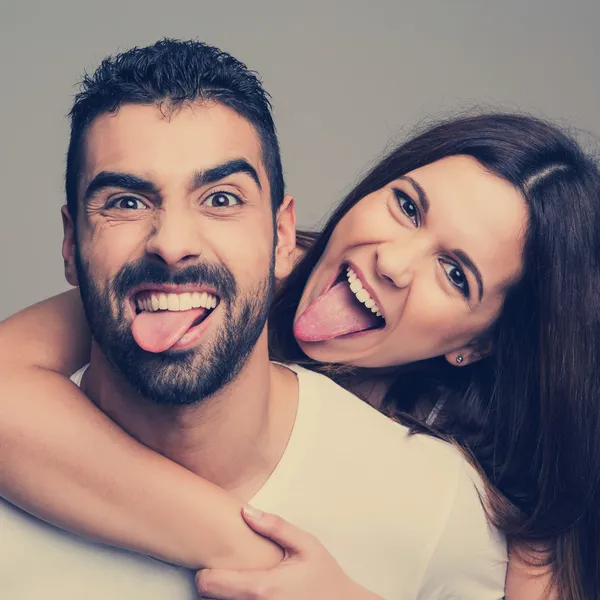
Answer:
[[0, 115, 600, 600]]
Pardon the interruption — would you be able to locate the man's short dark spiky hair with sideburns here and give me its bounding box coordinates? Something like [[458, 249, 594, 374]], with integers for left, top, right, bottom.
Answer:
[[65, 39, 284, 221]]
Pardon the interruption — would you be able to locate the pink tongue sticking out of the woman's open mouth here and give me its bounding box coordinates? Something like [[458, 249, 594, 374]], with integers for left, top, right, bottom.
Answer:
[[294, 281, 380, 342]]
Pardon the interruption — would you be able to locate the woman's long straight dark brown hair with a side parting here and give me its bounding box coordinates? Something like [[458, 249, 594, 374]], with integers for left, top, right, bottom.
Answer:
[[270, 114, 600, 600]]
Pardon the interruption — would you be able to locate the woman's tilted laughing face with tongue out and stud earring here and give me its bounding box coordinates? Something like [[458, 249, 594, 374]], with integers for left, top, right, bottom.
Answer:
[[294, 156, 527, 367]]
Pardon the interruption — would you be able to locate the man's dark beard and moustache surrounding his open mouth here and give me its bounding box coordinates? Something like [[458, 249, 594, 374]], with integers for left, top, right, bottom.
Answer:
[[75, 249, 274, 405]]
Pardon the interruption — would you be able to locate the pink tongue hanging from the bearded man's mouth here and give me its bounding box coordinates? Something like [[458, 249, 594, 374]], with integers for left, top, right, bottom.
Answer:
[[131, 308, 208, 353]]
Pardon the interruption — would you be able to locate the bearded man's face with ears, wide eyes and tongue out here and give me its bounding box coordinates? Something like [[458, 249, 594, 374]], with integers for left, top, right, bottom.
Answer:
[[63, 103, 294, 404]]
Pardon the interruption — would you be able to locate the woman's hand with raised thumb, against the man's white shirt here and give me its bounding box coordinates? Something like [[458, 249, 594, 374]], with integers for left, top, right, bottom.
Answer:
[[196, 507, 381, 600]]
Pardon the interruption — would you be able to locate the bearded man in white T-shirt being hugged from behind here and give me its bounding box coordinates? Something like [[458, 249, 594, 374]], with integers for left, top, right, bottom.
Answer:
[[0, 40, 505, 600]]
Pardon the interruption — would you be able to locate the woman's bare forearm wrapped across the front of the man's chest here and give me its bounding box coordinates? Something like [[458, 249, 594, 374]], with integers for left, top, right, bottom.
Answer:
[[0, 367, 282, 568]]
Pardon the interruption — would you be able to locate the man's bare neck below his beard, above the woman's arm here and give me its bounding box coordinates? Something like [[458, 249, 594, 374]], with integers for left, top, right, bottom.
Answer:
[[83, 335, 298, 500]]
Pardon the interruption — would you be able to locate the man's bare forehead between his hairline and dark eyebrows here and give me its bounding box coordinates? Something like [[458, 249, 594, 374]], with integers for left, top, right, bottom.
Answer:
[[83, 102, 267, 187]]
